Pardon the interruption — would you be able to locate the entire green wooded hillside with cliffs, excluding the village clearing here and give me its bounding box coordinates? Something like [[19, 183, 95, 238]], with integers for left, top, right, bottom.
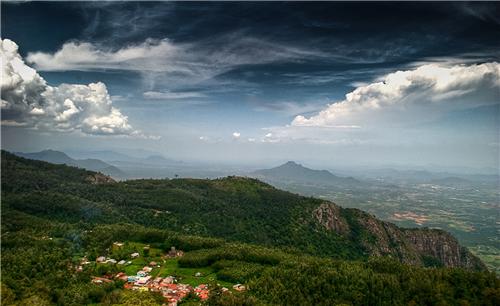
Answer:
[[2, 151, 500, 305]]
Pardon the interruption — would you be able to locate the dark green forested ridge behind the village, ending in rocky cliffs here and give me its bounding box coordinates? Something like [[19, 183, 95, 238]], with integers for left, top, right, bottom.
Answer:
[[2, 151, 485, 270]]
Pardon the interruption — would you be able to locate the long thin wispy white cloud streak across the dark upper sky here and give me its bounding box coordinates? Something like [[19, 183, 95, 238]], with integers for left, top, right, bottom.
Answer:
[[26, 33, 325, 85]]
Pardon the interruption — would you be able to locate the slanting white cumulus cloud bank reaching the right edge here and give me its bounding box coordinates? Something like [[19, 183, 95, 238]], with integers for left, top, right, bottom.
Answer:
[[292, 62, 500, 128]]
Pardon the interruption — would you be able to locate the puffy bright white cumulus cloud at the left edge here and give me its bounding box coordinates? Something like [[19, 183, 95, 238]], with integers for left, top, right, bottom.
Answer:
[[0, 39, 140, 135]]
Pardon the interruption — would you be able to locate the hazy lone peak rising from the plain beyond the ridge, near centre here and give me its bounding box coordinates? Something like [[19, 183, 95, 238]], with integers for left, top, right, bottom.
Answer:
[[250, 161, 361, 186]]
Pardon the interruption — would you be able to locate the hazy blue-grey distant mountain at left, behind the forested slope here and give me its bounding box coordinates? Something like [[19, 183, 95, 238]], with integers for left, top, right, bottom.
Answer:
[[14, 150, 125, 178]]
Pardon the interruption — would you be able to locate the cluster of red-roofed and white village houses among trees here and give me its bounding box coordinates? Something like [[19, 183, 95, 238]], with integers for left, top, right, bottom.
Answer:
[[82, 242, 246, 306]]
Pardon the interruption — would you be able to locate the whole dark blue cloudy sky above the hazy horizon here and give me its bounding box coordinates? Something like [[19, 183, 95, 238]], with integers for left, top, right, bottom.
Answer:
[[1, 1, 500, 171]]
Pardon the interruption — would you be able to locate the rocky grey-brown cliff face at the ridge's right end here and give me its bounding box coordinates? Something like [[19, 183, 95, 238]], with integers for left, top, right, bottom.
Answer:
[[313, 203, 486, 270]]
